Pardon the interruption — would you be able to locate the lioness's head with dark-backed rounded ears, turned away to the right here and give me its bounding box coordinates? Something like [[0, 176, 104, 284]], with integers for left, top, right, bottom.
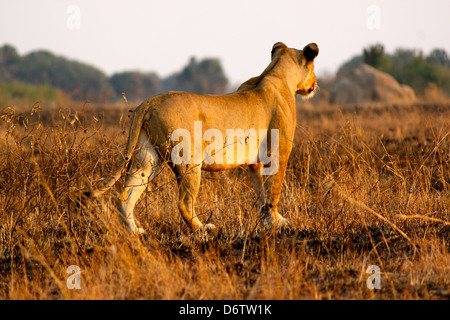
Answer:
[[268, 42, 319, 97]]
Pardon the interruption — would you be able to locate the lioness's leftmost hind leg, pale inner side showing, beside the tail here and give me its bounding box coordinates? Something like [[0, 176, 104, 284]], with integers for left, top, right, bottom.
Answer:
[[117, 131, 159, 233]]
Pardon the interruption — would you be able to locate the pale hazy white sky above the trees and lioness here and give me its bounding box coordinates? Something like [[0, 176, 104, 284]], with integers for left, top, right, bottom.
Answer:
[[0, 0, 450, 84]]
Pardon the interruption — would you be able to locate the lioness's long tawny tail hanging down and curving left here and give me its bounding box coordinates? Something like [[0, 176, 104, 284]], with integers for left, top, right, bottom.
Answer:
[[71, 101, 150, 198]]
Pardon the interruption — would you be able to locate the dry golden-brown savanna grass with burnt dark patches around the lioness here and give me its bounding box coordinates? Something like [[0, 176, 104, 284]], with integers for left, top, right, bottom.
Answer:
[[0, 98, 450, 299]]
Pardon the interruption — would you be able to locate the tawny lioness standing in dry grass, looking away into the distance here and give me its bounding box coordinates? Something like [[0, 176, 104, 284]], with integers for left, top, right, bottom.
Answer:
[[89, 42, 319, 233]]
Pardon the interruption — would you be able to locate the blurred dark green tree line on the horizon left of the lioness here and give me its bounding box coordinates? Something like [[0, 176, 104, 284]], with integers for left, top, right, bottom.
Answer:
[[0, 45, 228, 102]]
